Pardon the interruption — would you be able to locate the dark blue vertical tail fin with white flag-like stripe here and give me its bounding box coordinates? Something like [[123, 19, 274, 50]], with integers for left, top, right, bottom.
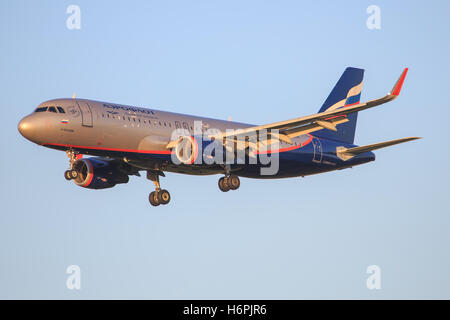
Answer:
[[314, 67, 364, 143]]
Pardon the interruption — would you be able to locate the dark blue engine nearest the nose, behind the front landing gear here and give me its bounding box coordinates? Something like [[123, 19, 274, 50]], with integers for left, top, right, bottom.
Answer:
[[73, 158, 129, 189]]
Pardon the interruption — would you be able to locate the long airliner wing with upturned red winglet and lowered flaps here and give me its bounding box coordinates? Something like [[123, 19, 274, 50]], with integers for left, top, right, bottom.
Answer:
[[210, 68, 408, 144]]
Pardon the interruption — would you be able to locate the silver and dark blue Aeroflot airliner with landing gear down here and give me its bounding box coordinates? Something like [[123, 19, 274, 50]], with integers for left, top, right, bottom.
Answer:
[[18, 67, 420, 206]]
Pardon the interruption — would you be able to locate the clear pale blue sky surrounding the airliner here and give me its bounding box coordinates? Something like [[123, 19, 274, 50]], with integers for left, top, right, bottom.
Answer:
[[0, 1, 450, 299]]
